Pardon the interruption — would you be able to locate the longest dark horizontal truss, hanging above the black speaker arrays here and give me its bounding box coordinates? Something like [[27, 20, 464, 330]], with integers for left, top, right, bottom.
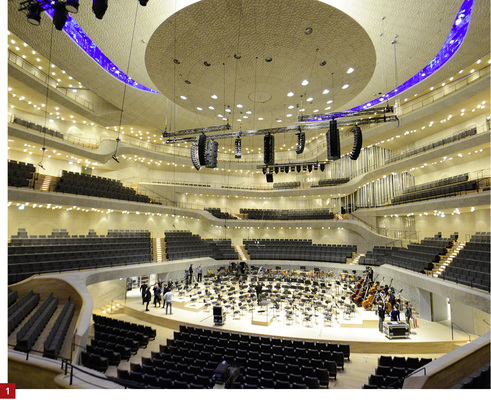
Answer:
[[164, 113, 399, 143]]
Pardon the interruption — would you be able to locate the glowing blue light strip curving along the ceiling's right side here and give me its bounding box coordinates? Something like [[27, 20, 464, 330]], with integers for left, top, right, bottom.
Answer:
[[306, 0, 474, 122]]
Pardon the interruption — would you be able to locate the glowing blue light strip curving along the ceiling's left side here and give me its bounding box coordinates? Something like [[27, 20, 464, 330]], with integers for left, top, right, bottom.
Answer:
[[44, 4, 160, 94]]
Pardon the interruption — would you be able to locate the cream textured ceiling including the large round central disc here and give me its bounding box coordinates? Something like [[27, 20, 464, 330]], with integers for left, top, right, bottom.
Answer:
[[8, 0, 490, 135]]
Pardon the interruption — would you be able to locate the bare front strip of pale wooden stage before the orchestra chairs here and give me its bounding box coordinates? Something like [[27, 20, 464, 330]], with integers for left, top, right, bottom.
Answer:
[[103, 289, 475, 354]]
